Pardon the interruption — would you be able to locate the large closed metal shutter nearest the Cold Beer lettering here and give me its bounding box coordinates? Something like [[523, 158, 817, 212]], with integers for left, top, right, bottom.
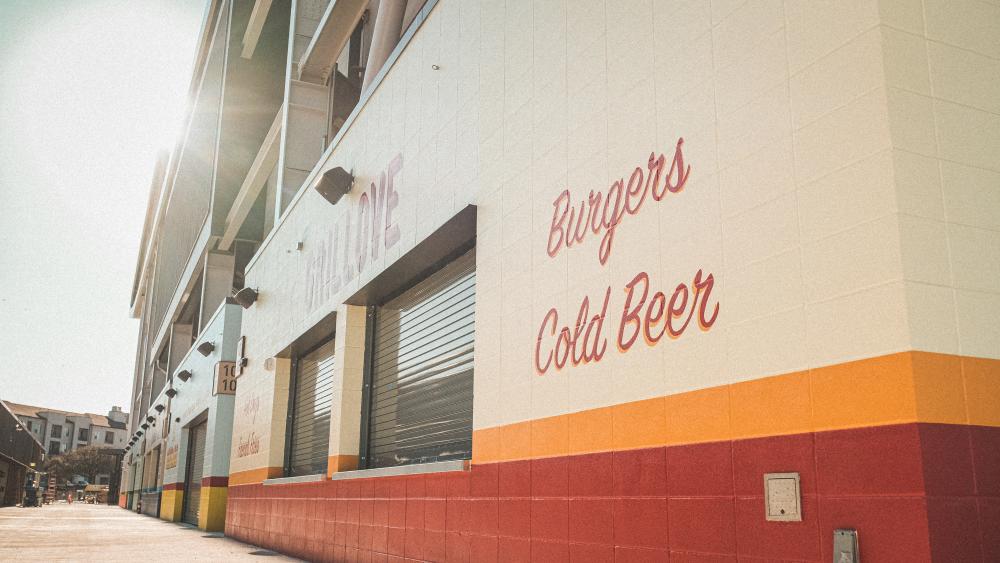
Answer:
[[366, 249, 476, 467]]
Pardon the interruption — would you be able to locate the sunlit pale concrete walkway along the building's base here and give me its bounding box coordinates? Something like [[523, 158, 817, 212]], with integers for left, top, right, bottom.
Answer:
[[0, 503, 297, 563]]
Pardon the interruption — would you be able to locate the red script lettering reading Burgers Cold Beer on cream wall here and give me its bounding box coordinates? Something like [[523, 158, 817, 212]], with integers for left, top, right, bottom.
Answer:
[[535, 138, 719, 375]]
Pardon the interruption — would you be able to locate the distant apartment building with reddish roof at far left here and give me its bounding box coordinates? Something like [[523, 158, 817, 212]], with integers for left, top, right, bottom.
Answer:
[[4, 401, 128, 485]]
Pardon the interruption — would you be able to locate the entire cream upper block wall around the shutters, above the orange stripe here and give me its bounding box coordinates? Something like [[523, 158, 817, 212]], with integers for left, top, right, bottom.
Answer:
[[225, 0, 1000, 468]]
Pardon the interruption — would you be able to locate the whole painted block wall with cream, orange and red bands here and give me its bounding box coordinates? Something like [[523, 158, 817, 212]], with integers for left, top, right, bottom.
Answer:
[[227, 0, 1000, 561]]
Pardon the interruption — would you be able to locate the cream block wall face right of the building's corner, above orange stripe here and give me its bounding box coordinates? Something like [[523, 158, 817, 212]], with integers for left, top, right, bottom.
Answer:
[[882, 0, 1000, 358]]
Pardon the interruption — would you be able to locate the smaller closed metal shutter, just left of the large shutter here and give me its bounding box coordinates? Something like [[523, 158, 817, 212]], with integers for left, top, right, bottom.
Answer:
[[288, 340, 334, 475]]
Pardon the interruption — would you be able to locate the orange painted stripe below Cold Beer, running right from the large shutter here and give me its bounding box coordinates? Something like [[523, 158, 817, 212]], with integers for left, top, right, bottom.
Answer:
[[472, 352, 1000, 463]]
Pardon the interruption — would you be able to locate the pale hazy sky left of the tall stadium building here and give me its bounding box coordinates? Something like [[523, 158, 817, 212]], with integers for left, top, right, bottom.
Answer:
[[0, 0, 206, 413]]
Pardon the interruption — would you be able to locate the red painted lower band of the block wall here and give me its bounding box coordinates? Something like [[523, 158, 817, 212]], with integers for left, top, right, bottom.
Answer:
[[226, 424, 1000, 563]]
